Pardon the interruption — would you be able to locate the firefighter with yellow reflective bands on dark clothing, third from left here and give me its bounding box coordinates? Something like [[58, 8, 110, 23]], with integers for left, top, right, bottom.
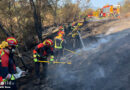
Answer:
[[55, 26, 65, 60]]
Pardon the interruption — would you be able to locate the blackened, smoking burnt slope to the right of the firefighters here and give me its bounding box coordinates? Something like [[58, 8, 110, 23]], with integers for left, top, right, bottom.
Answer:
[[19, 18, 130, 90]]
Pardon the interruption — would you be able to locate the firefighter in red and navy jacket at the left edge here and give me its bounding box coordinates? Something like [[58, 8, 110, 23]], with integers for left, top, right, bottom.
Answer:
[[0, 37, 25, 90]]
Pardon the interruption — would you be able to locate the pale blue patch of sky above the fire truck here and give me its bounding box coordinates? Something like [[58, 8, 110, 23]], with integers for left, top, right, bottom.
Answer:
[[90, 0, 124, 8]]
